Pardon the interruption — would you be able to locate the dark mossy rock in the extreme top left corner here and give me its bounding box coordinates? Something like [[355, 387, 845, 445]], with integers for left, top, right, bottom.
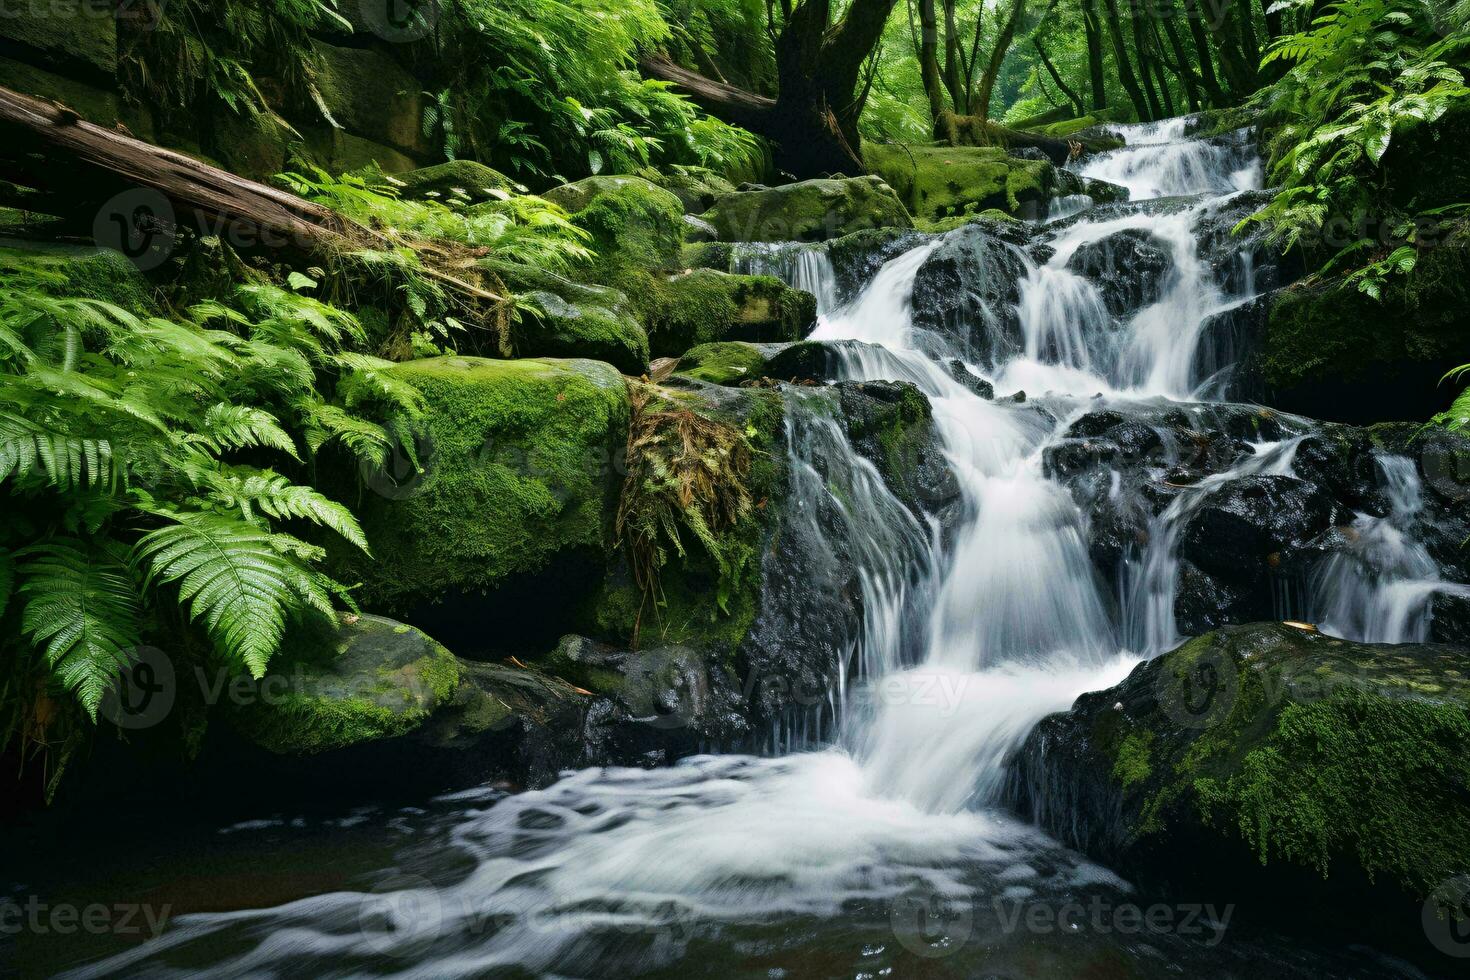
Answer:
[[0, 0, 118, 79]]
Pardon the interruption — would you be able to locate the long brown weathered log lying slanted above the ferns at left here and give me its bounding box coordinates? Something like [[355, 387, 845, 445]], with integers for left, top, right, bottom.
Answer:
[[0, 87, 506, 307]]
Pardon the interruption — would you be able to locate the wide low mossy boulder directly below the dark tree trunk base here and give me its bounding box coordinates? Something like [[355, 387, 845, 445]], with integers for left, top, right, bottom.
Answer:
[[703, 176, 913, 241]]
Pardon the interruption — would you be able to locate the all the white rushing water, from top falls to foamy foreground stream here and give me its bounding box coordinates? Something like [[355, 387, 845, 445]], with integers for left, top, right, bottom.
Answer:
[[54, 122, 1432, 977]]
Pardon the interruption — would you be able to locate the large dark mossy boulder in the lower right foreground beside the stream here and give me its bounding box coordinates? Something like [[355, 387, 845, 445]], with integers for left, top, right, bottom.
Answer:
[[1011, 624, 1470, 940]]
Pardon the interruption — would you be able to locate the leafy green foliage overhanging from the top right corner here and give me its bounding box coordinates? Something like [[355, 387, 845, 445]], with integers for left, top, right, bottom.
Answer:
[[1251, 0, 1470, 298]]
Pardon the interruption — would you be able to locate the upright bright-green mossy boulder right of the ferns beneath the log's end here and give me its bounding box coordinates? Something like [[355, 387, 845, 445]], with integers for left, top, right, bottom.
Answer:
[[542, 176, 685, 276]]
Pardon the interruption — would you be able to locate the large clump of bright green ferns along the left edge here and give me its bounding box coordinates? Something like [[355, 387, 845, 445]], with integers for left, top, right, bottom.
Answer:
[[0, 257, 420, 735]]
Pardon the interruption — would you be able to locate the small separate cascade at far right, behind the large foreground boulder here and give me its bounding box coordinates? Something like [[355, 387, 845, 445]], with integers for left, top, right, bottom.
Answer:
[[1310, 455, 1460, 644]]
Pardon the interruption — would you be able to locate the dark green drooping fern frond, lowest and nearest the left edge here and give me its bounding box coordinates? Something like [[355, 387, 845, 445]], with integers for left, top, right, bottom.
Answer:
[[18, 539, 140, 718]]
